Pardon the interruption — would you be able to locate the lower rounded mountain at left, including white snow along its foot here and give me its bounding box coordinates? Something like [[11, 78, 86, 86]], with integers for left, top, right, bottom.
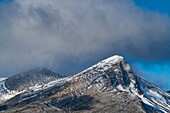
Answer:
[[0, 68, 62, 102]]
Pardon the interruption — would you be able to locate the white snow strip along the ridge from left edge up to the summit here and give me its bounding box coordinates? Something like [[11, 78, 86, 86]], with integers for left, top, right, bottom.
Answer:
[[0, 55, 124, 103]]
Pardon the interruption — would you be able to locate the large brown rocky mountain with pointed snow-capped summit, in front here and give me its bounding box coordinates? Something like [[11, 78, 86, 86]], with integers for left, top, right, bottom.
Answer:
[[0, 56, 170, 113]]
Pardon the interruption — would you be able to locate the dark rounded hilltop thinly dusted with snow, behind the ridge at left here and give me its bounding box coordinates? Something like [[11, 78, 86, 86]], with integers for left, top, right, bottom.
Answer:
[[5, 68, 62, 90]]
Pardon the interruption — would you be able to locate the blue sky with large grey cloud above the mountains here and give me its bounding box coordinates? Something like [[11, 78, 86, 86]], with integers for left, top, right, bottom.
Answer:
[[0, 0, 170, 90]]
